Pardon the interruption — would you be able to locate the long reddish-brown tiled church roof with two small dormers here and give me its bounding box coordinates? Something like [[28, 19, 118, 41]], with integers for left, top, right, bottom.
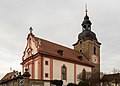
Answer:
[[35, 37, 93, 66]]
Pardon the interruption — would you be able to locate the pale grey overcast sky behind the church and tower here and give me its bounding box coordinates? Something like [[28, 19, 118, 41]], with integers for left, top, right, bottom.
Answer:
[[0, 0, 120, 78]]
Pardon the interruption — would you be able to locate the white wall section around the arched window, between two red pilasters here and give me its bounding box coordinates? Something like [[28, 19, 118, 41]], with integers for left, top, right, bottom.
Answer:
[[53, 59, 74, 85]]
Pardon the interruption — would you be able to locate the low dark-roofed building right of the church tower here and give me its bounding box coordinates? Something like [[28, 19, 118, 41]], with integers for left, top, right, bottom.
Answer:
[[101, 73, 120, 86]]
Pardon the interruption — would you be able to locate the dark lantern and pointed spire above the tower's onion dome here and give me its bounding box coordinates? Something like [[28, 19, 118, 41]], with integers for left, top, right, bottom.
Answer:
[[81, 4, 92, 31]]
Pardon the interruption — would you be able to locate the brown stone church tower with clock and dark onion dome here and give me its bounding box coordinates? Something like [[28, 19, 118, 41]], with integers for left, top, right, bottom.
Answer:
[[73, 8, 101, 85]]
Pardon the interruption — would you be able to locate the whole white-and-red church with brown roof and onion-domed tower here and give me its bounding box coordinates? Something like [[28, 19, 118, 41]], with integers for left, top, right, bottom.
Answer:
[[21, 7, 101, 85]]
